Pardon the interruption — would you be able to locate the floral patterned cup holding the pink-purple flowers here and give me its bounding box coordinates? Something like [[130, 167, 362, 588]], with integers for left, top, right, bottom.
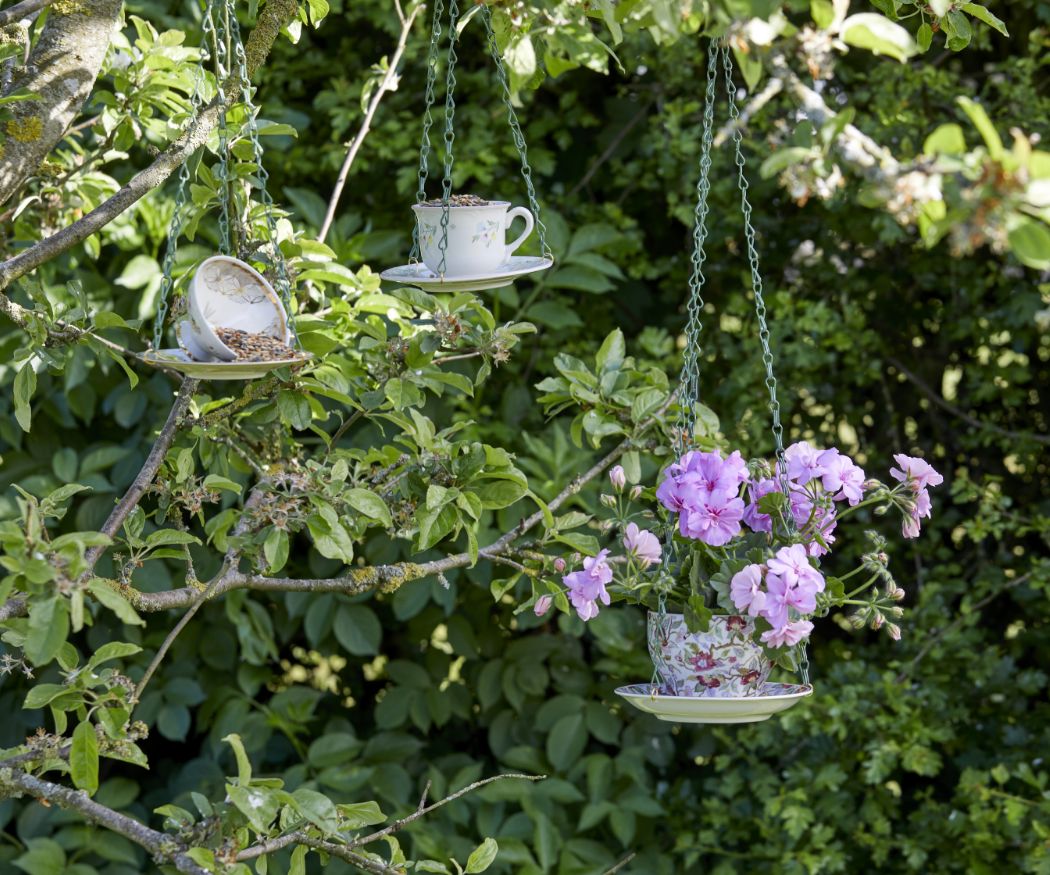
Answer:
[[649, 612, 773, 697]]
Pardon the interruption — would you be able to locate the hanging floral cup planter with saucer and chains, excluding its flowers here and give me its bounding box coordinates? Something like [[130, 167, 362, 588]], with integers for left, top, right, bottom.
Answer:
[[616, 41, 813, 724]]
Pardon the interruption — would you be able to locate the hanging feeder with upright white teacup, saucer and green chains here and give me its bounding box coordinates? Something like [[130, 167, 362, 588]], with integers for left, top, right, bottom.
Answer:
[[380, 0, 554, 292]]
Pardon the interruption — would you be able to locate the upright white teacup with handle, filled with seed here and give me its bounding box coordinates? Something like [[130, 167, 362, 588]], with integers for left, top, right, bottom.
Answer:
[[412, 201, 536, 276]]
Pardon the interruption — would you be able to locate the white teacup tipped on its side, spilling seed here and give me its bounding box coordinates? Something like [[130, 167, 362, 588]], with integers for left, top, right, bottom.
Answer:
[[179, 255, 292, 361]]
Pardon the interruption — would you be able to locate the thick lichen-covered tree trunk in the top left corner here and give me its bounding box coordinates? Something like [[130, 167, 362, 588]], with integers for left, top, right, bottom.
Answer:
[[0, 0, 123, 204]]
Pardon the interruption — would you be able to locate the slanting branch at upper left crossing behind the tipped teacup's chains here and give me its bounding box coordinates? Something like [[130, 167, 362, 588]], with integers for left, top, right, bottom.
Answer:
[[0, 0, 298, 296]]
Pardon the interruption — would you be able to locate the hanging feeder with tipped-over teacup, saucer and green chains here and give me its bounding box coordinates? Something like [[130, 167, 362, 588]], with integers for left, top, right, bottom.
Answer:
[[141, 0, 311, 380]]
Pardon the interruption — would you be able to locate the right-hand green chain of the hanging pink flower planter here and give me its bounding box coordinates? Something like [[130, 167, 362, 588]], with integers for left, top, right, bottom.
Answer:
[[718, 42, 810, 685]]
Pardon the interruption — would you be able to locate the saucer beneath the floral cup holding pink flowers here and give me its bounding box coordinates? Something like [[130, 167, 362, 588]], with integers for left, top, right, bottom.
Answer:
[[616, 684, 813, 723]]
